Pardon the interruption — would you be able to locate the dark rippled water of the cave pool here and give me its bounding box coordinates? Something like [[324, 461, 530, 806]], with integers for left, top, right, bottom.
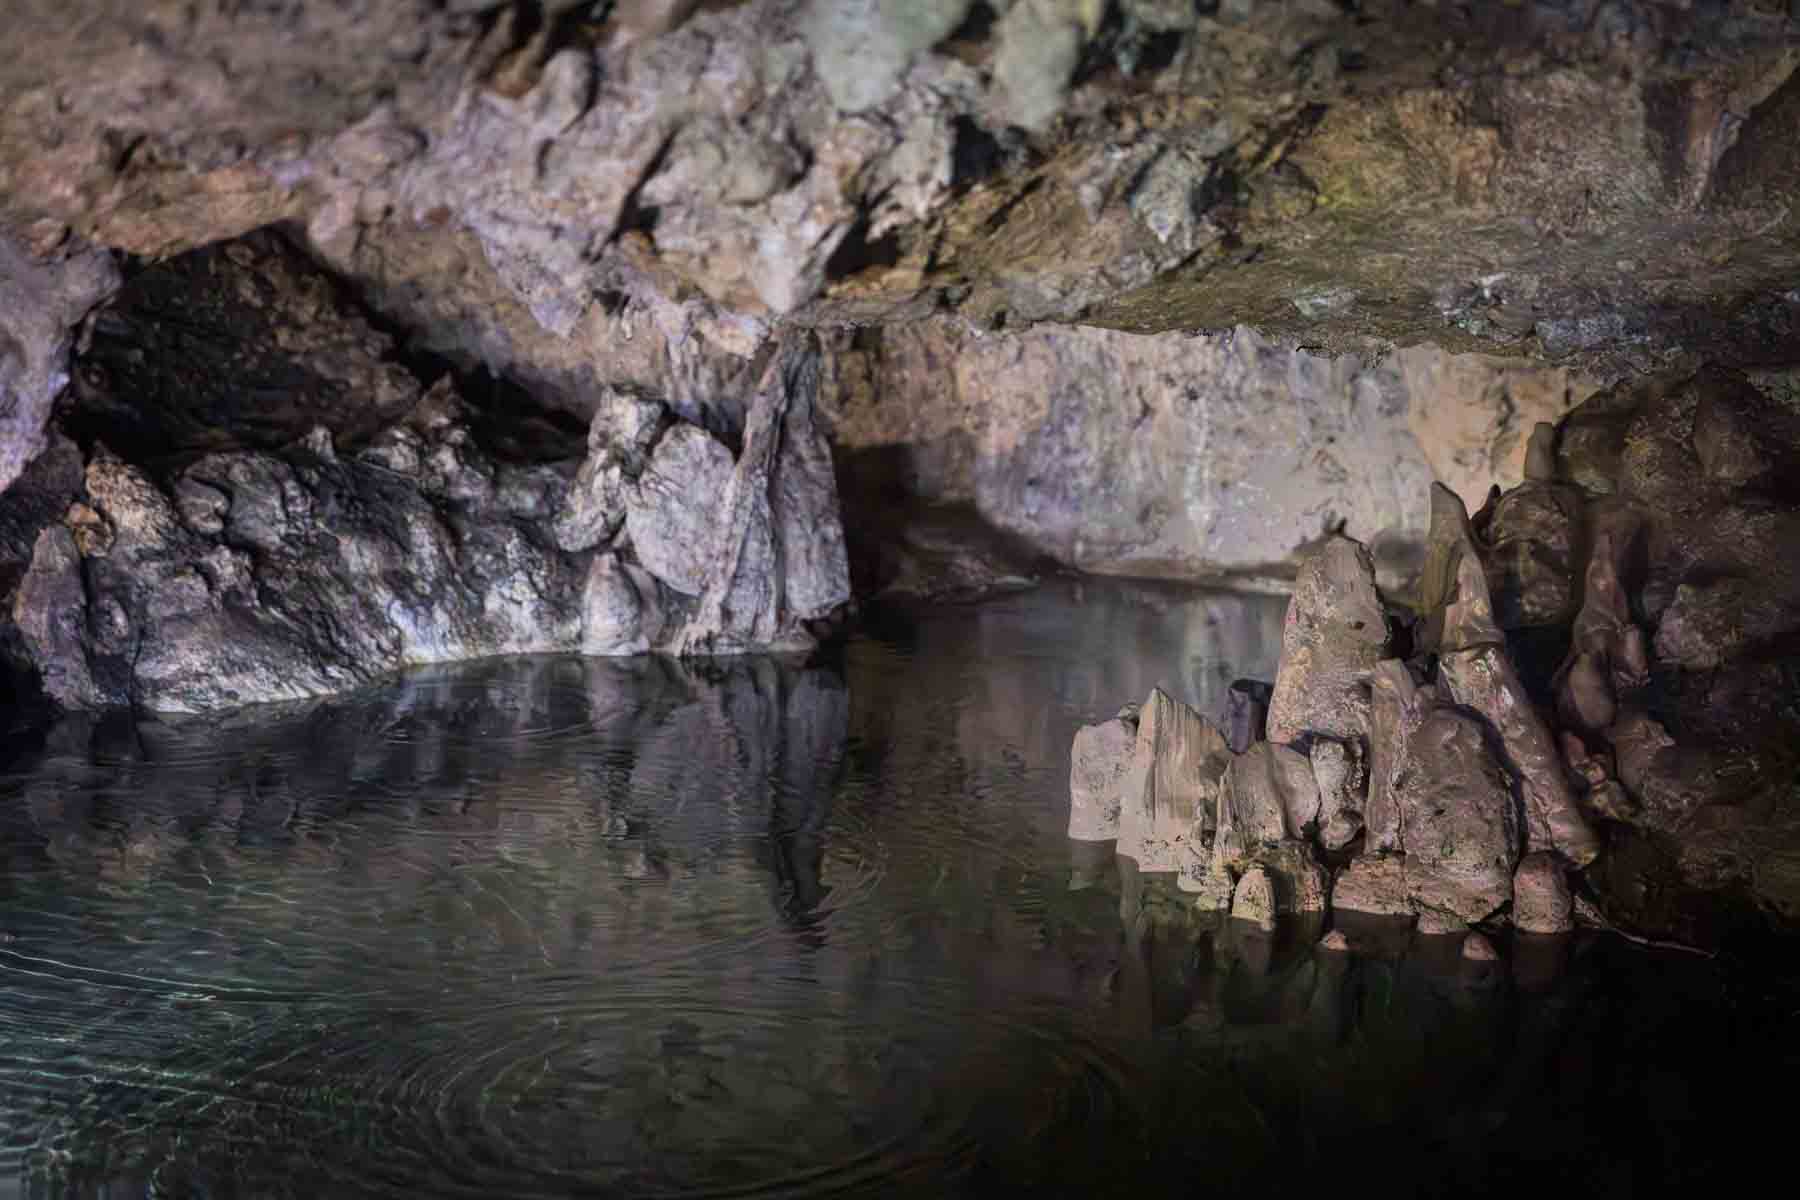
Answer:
[[0, 585, 1800, 1198]]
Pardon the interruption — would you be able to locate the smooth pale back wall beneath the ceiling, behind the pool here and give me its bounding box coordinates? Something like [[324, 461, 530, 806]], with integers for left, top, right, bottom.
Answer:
[[826, 318, 1588, 587]]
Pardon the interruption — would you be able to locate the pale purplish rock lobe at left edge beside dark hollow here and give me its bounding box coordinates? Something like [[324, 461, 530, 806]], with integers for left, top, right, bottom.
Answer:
[[0, 228, 119, 491]]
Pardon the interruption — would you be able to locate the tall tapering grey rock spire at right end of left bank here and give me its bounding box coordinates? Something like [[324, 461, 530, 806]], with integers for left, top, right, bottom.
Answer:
[[669, 336, 850, 653]]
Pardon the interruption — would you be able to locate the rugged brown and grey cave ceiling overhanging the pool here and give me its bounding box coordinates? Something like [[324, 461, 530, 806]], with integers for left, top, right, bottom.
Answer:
[[0, 0, 1796, 390]]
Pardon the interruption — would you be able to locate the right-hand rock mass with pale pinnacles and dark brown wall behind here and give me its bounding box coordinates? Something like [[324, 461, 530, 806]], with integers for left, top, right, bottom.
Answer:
[[1069, 371, 1800, 945]]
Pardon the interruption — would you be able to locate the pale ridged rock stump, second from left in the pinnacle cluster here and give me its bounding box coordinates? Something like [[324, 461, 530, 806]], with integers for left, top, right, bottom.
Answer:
[[1118, 687, 1231, 874]]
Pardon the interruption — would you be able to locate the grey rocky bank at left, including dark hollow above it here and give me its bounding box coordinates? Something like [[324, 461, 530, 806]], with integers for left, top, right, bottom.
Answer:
[[0, 237, 850, 712]]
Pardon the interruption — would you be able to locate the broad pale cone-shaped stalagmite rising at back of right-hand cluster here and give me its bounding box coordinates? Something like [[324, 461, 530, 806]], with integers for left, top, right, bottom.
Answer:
[[1269, 536, 1388, 743]]
